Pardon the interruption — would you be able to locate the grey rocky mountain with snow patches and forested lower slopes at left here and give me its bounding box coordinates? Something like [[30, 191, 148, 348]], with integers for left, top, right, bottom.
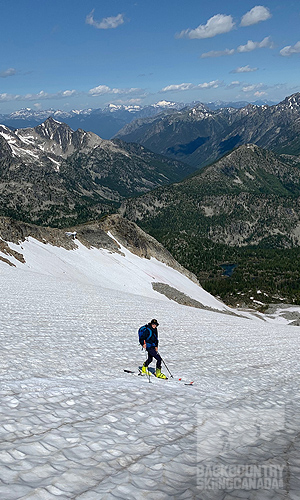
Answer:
[[0, 118, 193, 226]]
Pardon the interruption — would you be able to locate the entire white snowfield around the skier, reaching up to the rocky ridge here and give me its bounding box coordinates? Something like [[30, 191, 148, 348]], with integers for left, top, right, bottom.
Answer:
[[0, 238, 300, 500]]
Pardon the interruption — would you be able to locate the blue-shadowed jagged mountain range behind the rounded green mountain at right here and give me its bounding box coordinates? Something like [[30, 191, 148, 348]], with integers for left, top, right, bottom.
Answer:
[[117, 93, 300, 169]]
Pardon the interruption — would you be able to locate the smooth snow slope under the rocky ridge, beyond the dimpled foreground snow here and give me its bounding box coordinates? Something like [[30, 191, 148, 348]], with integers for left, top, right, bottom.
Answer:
[[0, 235, 230, 311]]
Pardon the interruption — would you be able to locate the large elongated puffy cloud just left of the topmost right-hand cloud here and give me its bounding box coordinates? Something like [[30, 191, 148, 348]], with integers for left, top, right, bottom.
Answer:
[[177, 14, 235, 38]]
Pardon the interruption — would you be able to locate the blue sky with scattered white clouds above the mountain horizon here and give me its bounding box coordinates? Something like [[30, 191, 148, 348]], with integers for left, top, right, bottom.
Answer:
[[0, 0, 300, 113]]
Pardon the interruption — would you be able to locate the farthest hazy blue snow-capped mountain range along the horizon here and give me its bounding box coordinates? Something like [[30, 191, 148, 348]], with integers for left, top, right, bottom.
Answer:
[[0, 100, 274, 139]]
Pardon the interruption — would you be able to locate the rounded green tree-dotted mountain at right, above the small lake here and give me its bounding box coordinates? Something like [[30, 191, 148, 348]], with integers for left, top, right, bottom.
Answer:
[[121, 144, 300, 247]]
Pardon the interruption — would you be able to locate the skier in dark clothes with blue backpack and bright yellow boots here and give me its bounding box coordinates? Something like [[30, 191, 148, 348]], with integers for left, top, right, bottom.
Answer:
[[139, 319, 167, 379]]
